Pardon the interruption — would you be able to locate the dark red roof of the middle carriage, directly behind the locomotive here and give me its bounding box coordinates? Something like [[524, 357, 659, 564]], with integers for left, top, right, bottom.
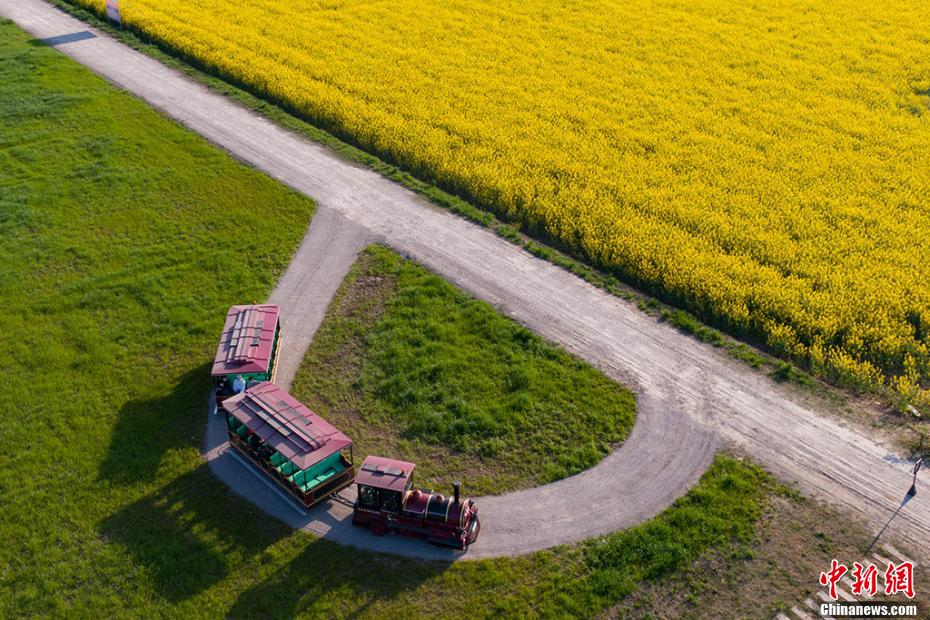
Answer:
[[223, 381, 352, 469]]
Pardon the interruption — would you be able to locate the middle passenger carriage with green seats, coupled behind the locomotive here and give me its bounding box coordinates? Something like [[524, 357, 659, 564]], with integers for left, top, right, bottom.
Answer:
[[224, 382, 355, 508]]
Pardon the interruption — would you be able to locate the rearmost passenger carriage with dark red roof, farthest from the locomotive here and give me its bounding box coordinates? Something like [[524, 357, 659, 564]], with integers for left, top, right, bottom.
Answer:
[[210, 304, 281, 408]]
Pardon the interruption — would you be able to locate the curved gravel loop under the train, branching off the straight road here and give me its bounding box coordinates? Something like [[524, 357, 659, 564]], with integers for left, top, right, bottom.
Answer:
[[204, 208, 718, 560]]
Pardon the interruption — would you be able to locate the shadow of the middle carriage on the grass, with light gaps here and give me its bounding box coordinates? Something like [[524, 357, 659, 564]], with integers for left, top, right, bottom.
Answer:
[[98, 464, 291, 602]]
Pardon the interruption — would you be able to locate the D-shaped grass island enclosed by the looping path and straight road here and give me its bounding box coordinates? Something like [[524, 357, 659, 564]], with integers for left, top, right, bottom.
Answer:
[[293, 246, 635, 494]]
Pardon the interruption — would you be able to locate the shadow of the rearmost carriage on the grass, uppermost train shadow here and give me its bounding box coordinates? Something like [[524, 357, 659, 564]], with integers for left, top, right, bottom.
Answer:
[[98, 364, 210, 484]]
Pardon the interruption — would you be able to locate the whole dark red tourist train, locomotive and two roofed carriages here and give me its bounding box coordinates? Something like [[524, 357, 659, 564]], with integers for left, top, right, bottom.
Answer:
[[211, 304, 481, 550]]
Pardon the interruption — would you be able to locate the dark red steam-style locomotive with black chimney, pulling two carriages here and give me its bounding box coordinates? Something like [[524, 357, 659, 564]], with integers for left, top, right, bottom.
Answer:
[[352, 456, 481, 549]]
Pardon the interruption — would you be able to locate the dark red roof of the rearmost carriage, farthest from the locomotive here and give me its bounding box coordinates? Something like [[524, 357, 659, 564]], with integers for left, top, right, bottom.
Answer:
[[211, 304, 280, 377]]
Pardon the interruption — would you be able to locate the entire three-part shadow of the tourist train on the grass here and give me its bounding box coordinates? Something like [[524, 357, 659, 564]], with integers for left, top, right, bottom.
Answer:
[[98, 364, 449, 604]]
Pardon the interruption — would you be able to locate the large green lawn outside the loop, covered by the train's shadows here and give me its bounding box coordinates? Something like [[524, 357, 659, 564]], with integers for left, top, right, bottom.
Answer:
[[0, 20, 916, 619]]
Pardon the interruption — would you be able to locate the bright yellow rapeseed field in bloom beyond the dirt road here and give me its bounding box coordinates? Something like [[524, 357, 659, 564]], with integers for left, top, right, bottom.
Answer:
[[78, 0, 930, 398]]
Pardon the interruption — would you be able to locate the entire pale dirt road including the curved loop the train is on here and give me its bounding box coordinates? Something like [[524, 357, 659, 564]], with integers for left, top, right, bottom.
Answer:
[[0, 0, 930, 560]]
